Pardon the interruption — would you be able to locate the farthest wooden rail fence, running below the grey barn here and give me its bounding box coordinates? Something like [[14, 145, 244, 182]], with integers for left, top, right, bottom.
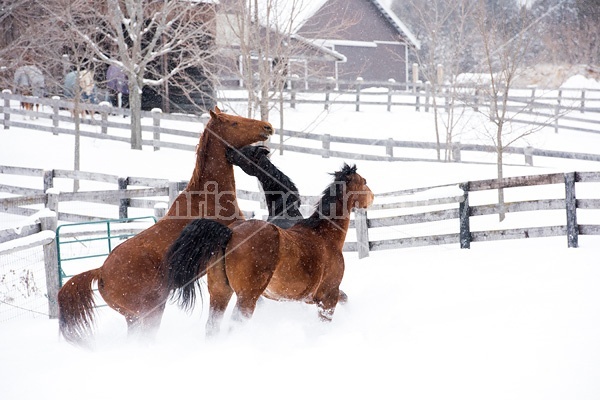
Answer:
[[218, 77, 600, 133]]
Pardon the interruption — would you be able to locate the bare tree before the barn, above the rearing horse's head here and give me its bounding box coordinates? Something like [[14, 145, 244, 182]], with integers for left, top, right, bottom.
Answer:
[[217, 0, 356, 119]]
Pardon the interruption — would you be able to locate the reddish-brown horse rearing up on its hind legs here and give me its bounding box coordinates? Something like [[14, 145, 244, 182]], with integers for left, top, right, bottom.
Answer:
[[58, 107, 273, 345]]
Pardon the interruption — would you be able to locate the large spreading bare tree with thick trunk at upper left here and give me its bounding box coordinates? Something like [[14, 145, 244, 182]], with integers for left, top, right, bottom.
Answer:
[[58, 0, 214, 149]]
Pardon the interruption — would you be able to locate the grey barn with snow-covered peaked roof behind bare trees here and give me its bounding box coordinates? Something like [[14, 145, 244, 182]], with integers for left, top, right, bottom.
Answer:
[[216, 0, 420, 87]]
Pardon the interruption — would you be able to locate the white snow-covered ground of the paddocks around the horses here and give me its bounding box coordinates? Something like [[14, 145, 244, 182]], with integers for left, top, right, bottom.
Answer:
[[0, 76, 600, 400]]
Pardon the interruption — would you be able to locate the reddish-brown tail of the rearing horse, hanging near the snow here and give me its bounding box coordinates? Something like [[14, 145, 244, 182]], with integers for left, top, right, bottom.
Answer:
[[58, 268, 100, 346]]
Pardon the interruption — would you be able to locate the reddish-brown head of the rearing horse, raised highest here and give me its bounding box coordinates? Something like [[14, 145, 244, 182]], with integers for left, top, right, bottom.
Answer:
[[206, 107, 273, 148]]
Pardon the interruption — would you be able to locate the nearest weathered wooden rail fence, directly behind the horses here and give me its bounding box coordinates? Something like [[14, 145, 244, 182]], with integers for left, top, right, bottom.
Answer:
[[0, 167, 600, 318]]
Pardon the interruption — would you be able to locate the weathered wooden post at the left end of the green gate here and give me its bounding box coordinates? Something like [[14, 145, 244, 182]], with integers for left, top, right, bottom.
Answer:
[[40, 206, 60, 319]]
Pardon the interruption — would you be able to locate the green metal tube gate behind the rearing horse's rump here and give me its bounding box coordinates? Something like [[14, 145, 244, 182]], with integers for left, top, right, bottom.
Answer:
[[56, 217, 156, 287]]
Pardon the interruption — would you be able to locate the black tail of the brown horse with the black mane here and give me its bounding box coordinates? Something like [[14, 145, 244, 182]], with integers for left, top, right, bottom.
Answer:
[[164, 218, 232, 310]]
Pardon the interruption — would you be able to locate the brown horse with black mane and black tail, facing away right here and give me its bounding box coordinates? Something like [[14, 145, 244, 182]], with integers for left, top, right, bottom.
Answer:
[[165, 165, 374, 336]]
